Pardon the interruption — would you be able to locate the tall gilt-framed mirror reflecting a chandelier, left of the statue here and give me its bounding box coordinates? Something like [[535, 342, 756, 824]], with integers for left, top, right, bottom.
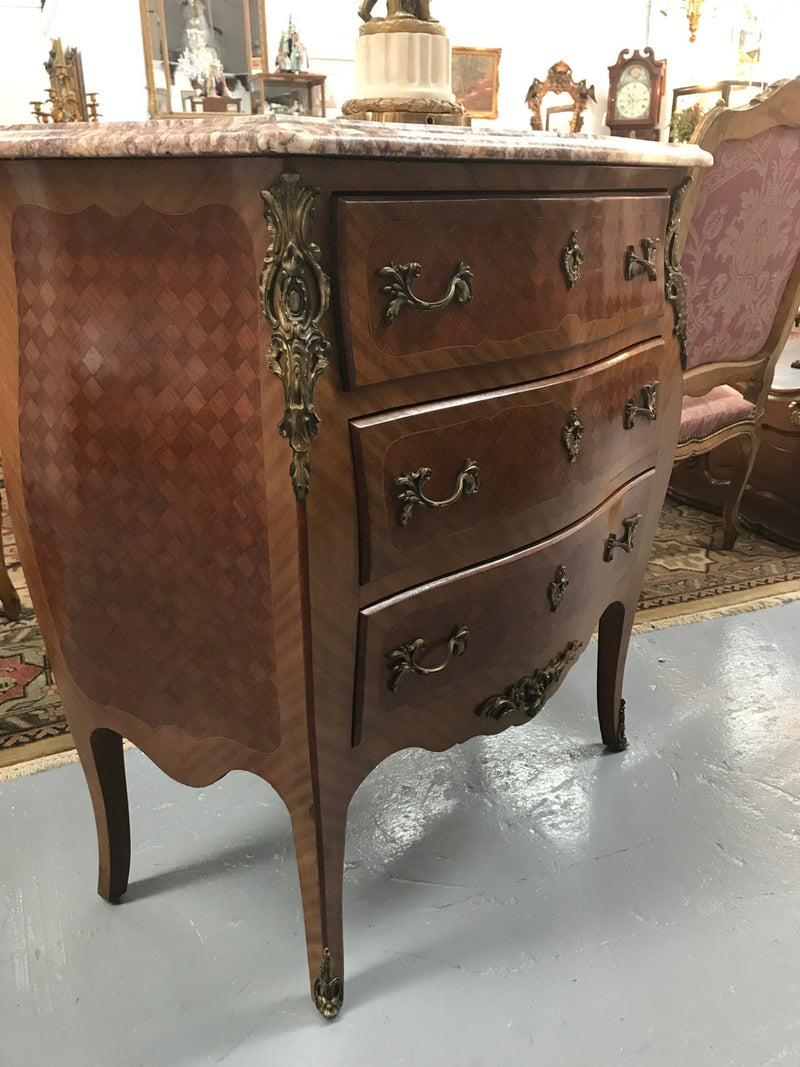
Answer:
[[140, 0, 269, 118]]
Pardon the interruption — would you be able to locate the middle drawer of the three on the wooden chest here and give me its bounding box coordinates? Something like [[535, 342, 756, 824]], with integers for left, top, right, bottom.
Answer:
[[351, 340, 665, 583]]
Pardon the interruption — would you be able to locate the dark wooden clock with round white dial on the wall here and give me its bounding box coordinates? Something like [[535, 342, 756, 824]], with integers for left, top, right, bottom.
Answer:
[[606, 48, 667, 141]]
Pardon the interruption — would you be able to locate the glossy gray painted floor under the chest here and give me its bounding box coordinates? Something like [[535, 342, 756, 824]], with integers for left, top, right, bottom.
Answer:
[[0, 602, 800, 1067]]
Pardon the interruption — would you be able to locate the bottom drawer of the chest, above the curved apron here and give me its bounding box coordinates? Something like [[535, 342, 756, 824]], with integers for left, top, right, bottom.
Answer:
[[353, 472, 653, 745]]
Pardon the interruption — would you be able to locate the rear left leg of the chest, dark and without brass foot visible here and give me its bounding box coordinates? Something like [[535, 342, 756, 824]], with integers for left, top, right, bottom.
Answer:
[[73, 729, 130, 904]]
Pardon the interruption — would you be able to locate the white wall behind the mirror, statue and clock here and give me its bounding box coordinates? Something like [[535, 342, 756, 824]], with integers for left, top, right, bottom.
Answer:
[[0, 0, 800, 133]]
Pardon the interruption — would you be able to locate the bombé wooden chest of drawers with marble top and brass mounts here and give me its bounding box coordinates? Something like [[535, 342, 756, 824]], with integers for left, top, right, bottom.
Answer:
[[0, 117, 708, 1017]]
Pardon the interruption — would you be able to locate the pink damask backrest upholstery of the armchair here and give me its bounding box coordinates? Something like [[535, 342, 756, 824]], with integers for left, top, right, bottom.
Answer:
[[682, 126, 800, 371]]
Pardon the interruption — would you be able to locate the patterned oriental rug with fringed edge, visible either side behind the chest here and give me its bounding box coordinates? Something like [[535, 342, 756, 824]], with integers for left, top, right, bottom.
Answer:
[[0, 478, 800, 779]]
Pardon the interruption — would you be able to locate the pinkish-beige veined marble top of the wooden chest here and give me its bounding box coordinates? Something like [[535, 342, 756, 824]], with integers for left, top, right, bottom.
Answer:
[[0, 115, 711, 166]]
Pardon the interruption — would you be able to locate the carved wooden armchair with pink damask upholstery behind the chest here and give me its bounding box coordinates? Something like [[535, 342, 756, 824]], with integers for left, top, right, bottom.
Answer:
[[670, 78, 800, 548]]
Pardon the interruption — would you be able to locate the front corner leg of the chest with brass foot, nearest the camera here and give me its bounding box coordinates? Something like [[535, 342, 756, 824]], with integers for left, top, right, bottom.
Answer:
[[291, 803, 347, 1019]]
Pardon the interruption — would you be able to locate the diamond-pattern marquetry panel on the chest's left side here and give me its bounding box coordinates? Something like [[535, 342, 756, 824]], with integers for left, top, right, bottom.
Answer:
[[13, 205, 278, 749]]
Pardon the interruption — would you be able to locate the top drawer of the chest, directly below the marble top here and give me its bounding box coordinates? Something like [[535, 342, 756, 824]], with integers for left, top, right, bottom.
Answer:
[[334, 194, 669, 388]]
